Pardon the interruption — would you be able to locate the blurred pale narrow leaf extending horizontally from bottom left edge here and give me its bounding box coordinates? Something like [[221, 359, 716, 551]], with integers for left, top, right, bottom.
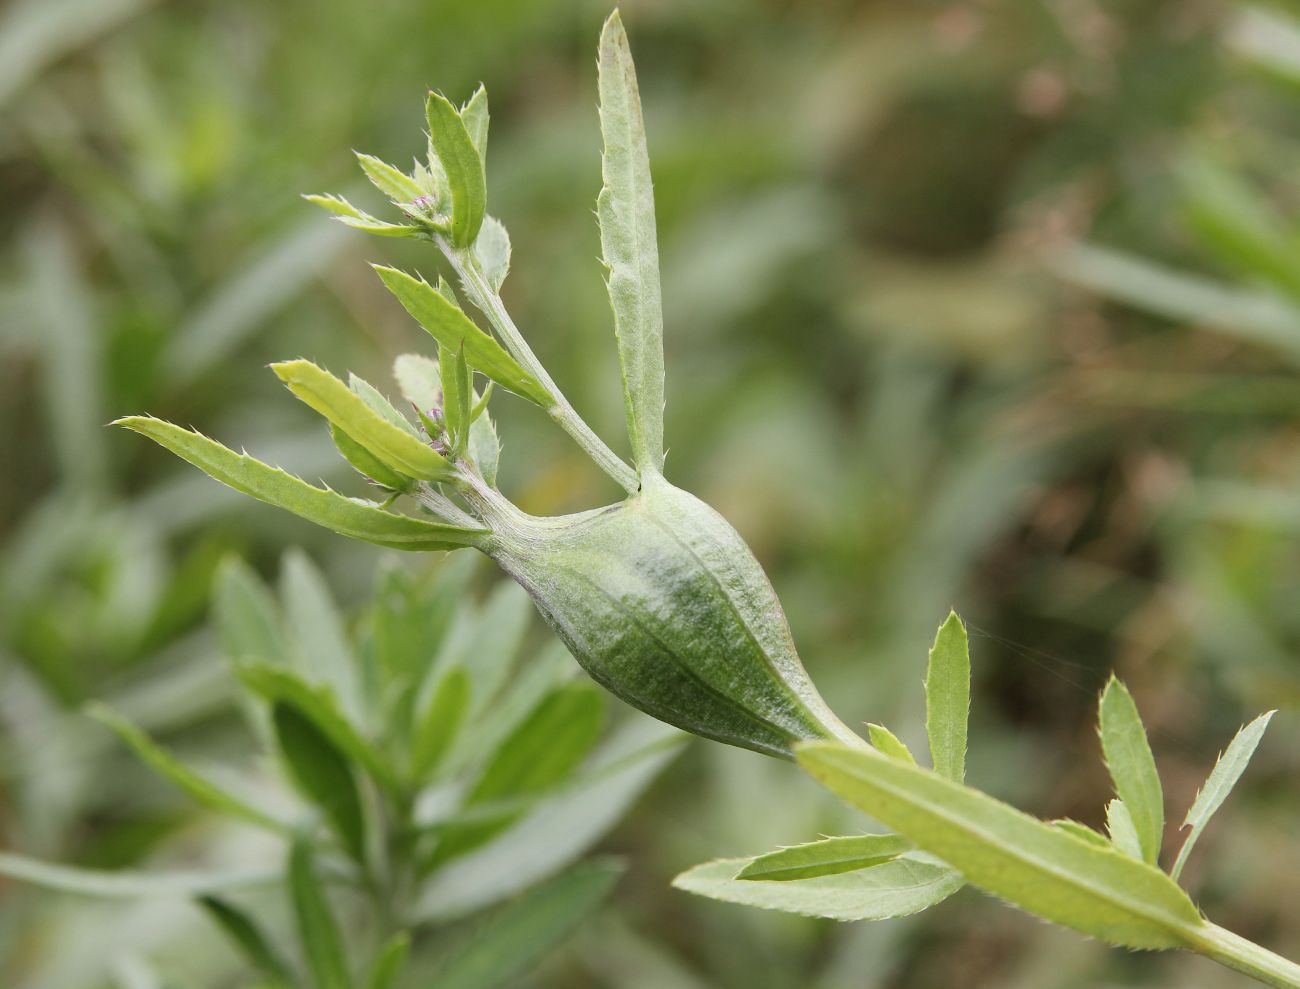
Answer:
[[0, 851, 271, 899]]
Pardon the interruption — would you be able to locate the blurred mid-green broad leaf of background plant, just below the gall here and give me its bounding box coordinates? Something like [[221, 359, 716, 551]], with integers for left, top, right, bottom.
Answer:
[[433, 681, 605, 866]]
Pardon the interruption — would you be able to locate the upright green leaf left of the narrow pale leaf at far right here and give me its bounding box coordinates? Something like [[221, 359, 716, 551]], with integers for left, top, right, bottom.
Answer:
[[1099, 676, 1165, 864]]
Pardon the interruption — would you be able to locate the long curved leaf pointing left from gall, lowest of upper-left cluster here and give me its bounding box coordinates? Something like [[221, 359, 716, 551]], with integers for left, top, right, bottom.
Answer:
[[114, 416, 490, 551]]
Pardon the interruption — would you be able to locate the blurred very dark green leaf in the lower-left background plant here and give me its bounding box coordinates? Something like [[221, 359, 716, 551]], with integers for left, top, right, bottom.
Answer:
[[270, 702, 365, 862]]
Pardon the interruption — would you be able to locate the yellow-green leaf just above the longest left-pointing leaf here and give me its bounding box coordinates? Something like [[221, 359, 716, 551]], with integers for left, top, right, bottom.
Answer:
[[270, 360, 455, 481]]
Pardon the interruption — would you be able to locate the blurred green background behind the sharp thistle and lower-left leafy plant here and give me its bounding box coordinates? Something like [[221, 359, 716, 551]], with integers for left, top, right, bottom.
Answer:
[[0, 0, 1300, 989]]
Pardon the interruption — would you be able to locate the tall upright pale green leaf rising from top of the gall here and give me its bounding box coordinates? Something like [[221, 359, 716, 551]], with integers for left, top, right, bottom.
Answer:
[[595, 10, 663, 473]]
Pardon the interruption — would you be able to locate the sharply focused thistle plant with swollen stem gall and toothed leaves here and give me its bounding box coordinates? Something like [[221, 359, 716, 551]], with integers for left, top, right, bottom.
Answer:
[[111, 13, 1300, 988]]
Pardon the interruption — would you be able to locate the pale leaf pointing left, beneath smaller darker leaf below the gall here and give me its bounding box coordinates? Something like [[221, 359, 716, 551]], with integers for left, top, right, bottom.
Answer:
[[672, 853, 965, 920]]
